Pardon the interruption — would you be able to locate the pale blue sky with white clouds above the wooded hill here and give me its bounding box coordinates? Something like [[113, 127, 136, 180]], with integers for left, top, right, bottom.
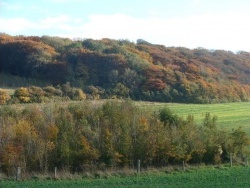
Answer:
[[0, 0, 250, 52]]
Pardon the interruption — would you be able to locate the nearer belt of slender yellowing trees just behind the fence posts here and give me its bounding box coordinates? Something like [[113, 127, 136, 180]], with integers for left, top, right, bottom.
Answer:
[[0, 101, 249, 174]]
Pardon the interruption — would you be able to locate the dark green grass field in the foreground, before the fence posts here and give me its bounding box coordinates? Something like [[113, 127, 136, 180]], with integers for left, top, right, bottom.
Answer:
[[0, 166, 250, 188]]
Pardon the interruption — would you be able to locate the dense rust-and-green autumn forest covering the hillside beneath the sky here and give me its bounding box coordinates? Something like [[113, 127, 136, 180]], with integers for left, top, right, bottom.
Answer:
[[0, 34, 250, 103]]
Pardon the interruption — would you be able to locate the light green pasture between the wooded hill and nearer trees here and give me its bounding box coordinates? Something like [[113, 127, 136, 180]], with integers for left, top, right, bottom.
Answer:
[[136, 102, 250, 135]]
